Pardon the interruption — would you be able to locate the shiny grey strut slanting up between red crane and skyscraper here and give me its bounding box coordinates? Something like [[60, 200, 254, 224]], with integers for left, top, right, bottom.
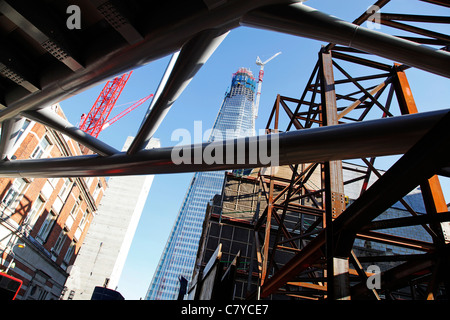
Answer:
[[128, 29, 228, 154]]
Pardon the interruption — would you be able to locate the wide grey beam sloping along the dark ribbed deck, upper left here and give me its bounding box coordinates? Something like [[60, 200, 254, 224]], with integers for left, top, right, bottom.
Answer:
[[0, 0, 294, 121]]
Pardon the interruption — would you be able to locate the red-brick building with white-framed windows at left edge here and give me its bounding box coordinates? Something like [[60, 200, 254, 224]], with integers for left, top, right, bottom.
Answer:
[[0, 105, 106, 300]]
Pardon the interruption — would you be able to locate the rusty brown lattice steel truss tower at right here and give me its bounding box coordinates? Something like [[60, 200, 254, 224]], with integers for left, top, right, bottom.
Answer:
[[253, 37, 450, 299]]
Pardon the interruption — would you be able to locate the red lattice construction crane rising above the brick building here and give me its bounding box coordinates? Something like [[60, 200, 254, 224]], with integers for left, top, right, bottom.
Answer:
[[80, 71, 153, 138]]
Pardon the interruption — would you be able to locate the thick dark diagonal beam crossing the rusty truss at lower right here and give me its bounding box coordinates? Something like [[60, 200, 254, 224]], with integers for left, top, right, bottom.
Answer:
[[261, 107, 450, 297]]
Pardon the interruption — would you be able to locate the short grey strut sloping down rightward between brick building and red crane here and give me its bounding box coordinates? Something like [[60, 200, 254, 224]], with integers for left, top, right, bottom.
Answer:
[[23, 107, 119, 156]]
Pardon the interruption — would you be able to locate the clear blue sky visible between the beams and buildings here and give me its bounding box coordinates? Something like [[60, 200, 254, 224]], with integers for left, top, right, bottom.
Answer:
[[61, 0, 450, 299]]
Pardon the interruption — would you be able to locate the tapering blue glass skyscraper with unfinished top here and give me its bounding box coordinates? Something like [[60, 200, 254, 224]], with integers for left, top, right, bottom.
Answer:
[[146, 68, 256, 300]]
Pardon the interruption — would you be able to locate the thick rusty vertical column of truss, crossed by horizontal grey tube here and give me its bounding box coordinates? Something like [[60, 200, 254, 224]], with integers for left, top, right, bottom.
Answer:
[[319, 49, 350, 300]]
